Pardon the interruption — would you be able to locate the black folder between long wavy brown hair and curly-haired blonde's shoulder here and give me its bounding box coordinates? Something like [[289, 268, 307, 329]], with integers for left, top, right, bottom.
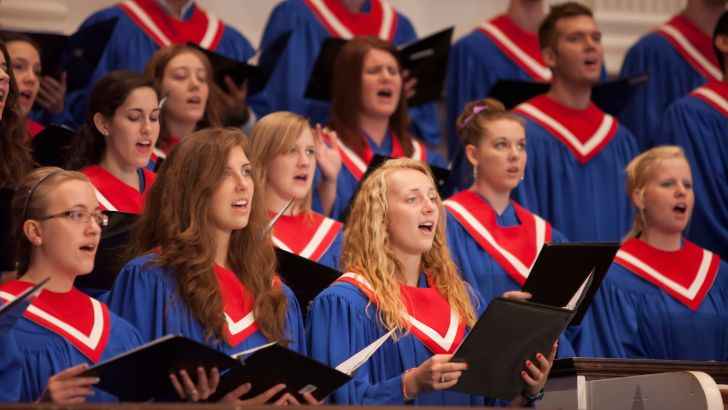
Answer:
[[276, 248, 341, 315]]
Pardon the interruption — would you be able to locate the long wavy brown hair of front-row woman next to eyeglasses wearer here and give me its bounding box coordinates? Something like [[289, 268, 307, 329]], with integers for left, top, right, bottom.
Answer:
[[131, 128, 287, 342]]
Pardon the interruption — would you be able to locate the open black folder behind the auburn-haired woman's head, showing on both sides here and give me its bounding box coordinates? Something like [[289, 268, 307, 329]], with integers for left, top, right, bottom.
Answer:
[[305, 27, 454, 107]]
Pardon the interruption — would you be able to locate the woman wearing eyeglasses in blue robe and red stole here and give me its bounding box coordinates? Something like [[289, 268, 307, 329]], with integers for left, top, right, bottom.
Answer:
[[0, 167, 218, 404]]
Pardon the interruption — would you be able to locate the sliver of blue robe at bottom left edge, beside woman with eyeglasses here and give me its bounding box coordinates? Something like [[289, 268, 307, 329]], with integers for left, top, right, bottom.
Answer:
[[0, 302, 23, 403]]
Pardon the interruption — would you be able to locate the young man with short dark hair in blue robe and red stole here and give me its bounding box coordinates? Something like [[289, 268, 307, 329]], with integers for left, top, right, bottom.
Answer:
[[515, 2, 637, 241]]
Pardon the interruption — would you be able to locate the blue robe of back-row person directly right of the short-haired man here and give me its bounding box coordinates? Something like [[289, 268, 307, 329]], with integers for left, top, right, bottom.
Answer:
[[620, 33, 705, 151]]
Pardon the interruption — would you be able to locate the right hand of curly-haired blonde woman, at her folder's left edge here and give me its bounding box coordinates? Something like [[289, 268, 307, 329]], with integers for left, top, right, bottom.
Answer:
[[402, 354, 468, 397]]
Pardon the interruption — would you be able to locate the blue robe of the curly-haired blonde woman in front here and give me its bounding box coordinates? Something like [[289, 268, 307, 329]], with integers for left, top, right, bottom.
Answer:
[[307, 283, 507, 406]]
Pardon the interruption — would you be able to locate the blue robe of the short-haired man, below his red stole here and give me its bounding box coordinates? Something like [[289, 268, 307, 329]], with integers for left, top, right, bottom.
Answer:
[[514, 119, 637, 242]]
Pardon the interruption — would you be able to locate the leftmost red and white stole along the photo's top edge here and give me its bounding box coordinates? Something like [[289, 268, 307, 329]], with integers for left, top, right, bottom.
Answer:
[[119, 0, 225, 50]]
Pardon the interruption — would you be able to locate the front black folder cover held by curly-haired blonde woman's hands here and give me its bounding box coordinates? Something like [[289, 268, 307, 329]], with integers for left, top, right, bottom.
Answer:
[[452, 297, 574, 400]]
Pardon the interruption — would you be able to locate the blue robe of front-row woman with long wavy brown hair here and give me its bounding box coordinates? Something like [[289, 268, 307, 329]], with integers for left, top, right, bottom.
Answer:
[[109, 254, 306, 354]]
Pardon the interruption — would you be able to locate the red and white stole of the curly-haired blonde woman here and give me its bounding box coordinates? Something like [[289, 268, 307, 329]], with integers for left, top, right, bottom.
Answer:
[[337, 272, 465, 354]]
